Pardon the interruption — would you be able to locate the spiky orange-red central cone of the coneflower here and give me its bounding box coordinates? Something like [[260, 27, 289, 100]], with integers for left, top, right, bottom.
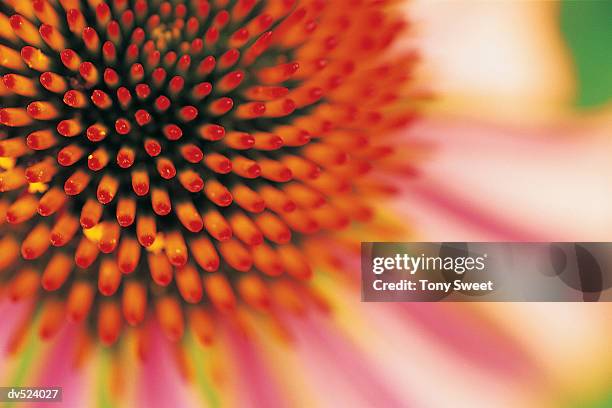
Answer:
[[0, 0, 414, 344]]
